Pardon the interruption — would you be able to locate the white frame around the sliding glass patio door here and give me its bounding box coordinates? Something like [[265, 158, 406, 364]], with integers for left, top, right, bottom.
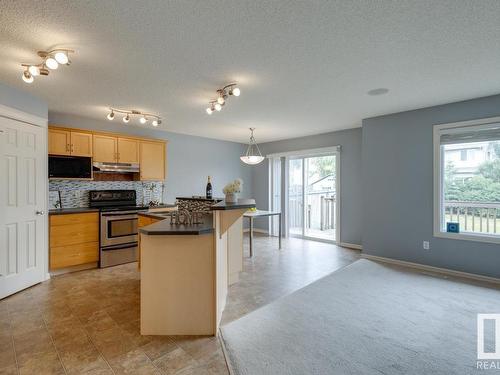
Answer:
[[267, 145, 342, 245]]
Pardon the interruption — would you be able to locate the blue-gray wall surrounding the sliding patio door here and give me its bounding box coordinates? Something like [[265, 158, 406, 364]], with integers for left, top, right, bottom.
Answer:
[[252, 128, 363, 244]]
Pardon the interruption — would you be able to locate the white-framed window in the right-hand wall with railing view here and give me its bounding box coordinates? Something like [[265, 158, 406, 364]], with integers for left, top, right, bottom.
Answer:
[[434, 118, 500, 247]]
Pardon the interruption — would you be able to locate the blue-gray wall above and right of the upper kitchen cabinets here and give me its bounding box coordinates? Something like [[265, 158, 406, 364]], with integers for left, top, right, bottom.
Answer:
[[49, 112, 252, 202]]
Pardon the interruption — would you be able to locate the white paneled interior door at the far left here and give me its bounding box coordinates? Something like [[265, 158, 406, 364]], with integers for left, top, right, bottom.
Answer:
[[0, 117, 47, 298]]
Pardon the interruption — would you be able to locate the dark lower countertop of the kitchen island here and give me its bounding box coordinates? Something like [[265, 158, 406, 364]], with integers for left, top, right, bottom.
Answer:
[[139, 212, 214, 236]]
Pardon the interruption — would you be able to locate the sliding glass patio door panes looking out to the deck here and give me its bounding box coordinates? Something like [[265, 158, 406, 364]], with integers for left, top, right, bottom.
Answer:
[[287, 152, 339, 242]]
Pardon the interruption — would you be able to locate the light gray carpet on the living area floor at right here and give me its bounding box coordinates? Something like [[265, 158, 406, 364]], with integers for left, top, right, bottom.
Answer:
[[221, 259, 500, 375]]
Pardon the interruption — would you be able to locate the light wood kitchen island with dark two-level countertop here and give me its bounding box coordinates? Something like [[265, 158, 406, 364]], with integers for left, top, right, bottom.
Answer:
[[140, 199, 255, 335]]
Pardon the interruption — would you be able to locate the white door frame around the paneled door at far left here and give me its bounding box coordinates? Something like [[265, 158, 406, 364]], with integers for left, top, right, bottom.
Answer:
[[0, 104, 50, 281]]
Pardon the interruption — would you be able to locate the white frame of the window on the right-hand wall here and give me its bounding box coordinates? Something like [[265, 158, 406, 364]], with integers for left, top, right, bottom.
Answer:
[[433, 116, 500, 243]]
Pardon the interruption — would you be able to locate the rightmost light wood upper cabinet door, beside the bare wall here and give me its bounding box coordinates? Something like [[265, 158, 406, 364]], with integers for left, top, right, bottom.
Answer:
[[139, 141, 166, 181]]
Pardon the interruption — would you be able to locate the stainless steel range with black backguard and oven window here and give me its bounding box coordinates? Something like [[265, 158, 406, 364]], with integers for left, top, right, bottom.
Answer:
[[89, 190, 148, 268]]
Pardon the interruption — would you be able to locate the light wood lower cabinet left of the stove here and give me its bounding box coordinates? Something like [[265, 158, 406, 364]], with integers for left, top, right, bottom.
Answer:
[[49, 212, 99, 270]]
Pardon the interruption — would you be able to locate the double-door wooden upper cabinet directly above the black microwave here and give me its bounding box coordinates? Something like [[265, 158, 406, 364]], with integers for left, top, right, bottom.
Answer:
[[49, 128, 92, 157]]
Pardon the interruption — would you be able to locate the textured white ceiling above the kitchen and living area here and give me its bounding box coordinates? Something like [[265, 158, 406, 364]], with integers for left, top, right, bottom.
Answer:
[[0, 0, 500, 142]]
